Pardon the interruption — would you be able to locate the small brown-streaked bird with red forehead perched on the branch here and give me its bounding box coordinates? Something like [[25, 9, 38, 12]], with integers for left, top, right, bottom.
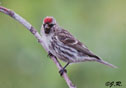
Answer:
[[41, 16, 116, 75]]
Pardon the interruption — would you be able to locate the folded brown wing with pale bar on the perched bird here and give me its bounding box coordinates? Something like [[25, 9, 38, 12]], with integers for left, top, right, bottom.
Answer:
[[56, 29, 100, 59]]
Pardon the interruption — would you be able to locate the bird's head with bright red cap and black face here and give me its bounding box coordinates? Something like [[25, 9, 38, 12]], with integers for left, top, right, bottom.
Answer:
[[43, 16, 56, 34]]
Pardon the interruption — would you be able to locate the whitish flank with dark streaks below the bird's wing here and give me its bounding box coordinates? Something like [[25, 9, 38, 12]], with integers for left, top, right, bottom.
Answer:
[[49, 42, 85, 63]]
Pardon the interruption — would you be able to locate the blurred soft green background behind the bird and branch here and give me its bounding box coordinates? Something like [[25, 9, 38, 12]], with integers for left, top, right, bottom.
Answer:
[[0, 0, 126, 88]]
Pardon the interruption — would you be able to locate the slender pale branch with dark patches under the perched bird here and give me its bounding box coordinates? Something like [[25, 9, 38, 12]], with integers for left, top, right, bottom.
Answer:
[[0, 6, 76, 88]]
